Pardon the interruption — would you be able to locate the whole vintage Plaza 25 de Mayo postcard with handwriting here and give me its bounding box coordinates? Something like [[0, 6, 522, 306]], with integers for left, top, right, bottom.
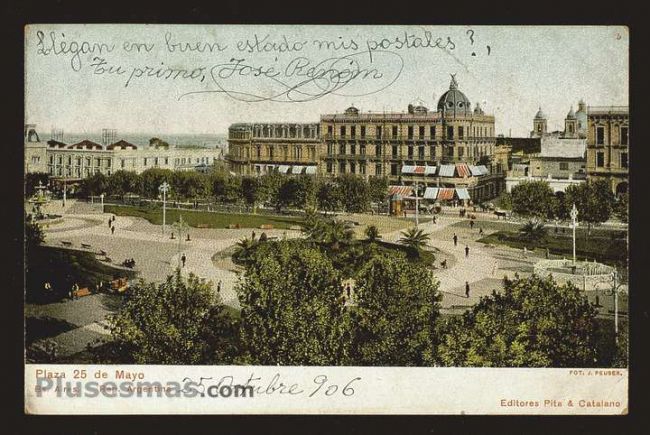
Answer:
[[24, 24, 630, 415]]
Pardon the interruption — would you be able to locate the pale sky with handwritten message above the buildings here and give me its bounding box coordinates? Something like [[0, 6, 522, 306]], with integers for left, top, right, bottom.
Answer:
[[25, 25, 629, 137]]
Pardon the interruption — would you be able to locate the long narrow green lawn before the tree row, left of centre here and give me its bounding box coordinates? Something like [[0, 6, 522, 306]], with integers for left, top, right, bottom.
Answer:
[[105, 205, 302, 229]]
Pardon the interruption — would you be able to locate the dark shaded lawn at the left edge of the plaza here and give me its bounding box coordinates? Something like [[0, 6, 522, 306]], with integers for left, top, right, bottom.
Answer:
[[25, 246, 135, 303]]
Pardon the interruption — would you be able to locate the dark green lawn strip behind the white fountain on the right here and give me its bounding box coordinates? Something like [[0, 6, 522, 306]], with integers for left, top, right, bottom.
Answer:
[[478, 231, 627, 266]]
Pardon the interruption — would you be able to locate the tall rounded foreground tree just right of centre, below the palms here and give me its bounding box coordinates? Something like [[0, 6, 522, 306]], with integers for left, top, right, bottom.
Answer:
[[350, 254, 441, 366]]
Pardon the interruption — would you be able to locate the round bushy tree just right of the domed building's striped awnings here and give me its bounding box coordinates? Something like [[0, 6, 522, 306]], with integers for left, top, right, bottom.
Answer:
[[511, 181, 555, 219]]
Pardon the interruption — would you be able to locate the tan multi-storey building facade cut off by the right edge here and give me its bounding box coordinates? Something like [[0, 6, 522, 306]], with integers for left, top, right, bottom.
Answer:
[[587, 106, 630, 195]]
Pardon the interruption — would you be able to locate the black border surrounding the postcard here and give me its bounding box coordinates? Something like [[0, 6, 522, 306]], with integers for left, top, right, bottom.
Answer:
[[6, 0, 650, 434]]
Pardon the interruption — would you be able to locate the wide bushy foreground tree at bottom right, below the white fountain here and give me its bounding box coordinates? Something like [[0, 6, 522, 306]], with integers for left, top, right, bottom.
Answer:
[[438, 275, 598, 367]]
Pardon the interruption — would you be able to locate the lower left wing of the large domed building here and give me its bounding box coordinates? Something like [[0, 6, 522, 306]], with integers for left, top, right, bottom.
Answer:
[[226, 123, 321, 175]]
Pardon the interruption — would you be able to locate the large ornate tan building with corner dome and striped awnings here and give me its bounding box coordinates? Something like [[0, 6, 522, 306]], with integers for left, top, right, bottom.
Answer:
[[228, 76, 503, 201]]
